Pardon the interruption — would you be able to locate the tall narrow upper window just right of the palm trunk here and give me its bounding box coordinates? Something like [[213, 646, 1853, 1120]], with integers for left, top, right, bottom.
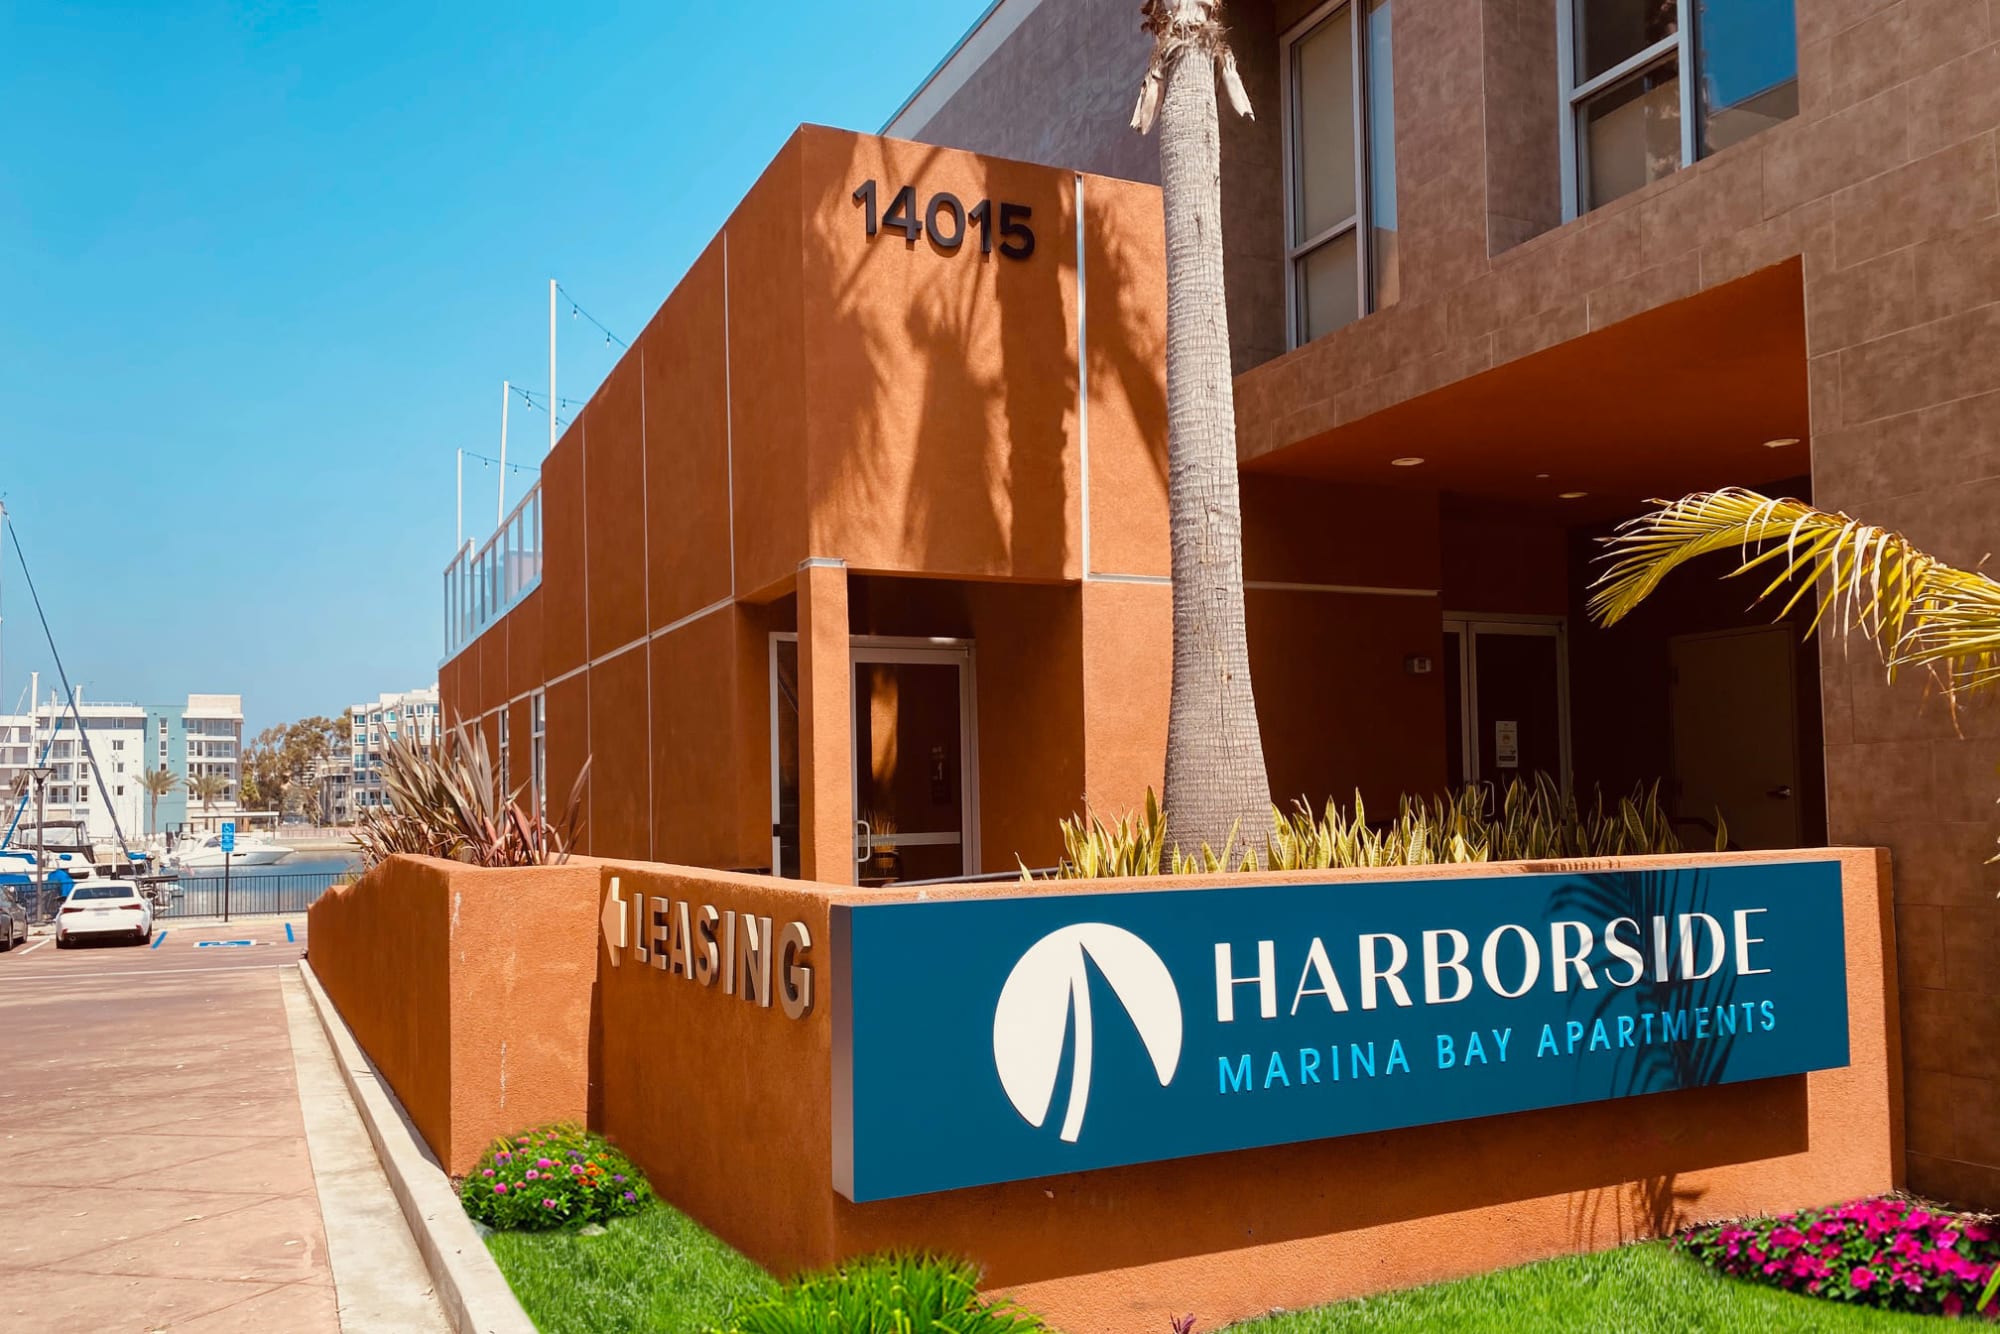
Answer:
[[1284, 0, 1400, 346]]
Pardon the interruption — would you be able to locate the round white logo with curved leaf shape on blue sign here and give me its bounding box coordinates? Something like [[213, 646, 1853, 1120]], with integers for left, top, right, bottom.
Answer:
[[994, 922, 1180, 1144]]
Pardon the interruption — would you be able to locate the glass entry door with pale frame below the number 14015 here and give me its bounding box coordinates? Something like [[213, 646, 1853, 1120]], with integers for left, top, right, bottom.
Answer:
[[854, 640, 978, 884]]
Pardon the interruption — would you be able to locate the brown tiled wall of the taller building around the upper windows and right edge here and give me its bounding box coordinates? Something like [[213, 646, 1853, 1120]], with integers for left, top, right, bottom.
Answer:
[[900, 0, 2000, 1204]]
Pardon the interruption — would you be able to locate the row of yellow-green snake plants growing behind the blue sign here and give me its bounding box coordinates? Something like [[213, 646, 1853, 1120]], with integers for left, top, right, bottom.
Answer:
[[1032, 774, 1728, 880]]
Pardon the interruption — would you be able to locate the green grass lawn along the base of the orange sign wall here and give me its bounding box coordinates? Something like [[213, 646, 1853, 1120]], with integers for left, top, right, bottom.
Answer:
[[486, 1204, 1946, 1334]]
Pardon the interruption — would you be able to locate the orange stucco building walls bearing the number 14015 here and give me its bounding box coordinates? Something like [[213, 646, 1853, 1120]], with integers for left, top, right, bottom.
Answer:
[[440, 126, 1166, 876]]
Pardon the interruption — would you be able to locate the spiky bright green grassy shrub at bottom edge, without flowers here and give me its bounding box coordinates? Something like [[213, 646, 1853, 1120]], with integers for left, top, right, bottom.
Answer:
[[730, 1256, 1046, 1334]]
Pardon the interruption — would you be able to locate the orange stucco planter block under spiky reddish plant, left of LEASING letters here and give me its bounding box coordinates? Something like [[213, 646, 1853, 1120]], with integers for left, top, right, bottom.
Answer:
[[308, 858, 598, 1172]]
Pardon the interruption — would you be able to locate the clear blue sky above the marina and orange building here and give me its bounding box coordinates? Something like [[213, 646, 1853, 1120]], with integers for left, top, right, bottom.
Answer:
[[0, 0, 986, 728]]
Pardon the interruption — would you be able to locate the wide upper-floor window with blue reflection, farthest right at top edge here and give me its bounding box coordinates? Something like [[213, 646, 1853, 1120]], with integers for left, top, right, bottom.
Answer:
[[1556, 0, 1798, 218]]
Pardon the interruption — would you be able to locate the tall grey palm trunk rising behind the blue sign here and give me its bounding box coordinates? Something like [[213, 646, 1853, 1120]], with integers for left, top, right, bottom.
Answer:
[[1132, 0, 1270, 850]]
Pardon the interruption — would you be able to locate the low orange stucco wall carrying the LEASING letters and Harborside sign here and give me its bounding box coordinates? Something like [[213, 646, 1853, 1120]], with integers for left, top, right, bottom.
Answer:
[[312, 850, 1902, 1334]]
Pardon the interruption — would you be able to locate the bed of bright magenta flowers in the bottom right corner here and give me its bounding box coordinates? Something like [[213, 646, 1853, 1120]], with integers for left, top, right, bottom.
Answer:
[[1674, 1196, 2000, 1320]]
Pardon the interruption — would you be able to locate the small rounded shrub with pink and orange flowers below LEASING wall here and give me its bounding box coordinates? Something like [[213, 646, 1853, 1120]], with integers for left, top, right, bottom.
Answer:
[[458, 1126, 652, 1232]]
